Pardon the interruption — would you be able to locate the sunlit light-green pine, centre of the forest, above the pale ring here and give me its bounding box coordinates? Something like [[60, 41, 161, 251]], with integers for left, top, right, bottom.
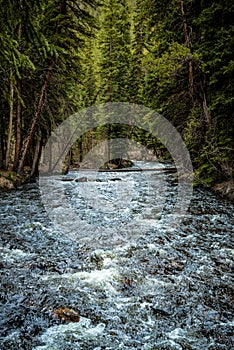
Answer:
[[98, 0, 131, 102]]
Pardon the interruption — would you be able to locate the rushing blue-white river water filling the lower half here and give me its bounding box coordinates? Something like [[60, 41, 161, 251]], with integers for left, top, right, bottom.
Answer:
[[0, 164, 234, 350]]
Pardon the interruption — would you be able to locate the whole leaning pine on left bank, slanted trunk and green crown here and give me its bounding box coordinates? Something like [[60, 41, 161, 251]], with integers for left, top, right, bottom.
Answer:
[[17, 0, 100, 173]]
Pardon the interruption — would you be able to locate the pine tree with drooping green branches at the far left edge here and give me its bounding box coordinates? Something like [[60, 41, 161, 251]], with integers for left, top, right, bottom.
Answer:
[[0, 0, 41, 168]]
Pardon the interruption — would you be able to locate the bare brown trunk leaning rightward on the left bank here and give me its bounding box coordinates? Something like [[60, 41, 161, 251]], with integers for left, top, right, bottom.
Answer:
[[17, 60, 55, 174]]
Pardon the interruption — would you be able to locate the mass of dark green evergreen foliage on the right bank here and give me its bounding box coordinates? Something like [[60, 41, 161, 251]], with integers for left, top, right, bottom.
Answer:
[[131, 0, 234, 186]]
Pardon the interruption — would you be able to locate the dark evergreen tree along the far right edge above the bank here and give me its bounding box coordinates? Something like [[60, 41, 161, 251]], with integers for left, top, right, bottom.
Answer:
[[194, 0, 234, 184]]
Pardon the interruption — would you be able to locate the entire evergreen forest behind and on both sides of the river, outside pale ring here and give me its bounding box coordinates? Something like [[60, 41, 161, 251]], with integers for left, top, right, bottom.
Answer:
[[0, 0, 234, 191]]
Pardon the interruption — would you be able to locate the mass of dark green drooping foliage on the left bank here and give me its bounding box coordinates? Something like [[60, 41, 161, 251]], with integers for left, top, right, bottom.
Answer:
[[0, 0, 98, 171]]
